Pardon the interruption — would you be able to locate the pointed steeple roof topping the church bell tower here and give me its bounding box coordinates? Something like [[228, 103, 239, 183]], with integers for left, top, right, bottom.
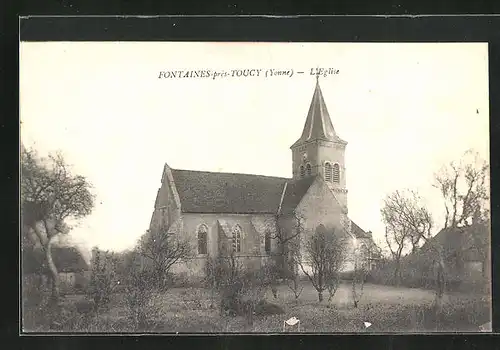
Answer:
[[292, 77, 346, 147]]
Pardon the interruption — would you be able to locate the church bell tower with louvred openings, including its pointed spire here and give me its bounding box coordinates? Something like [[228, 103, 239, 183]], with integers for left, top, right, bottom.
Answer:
[[290, 79, 347, 211]]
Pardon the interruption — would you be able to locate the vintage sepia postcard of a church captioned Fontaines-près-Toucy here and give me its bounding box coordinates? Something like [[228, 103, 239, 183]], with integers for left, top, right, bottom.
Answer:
[[20, 42, 491, 334]]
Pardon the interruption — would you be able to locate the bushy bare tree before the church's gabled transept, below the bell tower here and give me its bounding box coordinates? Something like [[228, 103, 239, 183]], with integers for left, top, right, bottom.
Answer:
[[299, 225, 346, 302]]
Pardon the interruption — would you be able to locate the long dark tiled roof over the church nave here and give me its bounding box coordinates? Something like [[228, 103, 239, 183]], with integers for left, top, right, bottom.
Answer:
[[172, 169, 290, 214]]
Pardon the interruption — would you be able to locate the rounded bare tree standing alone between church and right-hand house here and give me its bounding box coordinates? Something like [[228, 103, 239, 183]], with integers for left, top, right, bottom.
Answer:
[[381, 191, 432, 284]]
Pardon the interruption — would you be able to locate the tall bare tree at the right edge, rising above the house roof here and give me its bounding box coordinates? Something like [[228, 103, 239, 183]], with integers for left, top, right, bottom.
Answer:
[[434, 150, 489, 228]]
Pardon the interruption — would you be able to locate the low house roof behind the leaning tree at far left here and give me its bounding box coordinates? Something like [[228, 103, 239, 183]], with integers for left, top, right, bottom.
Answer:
[[23, 247, 89, 273]]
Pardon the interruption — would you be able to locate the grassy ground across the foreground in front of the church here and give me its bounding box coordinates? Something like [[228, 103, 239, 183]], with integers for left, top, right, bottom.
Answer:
[[53, 283, 491, 333]]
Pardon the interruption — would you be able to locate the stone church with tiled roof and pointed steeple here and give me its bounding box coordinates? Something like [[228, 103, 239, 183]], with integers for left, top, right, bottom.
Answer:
[[150, 81, 379, 276]]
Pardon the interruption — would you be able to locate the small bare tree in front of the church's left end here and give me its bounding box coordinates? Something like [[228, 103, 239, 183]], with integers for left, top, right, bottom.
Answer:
[[138, 230, 193, 290]]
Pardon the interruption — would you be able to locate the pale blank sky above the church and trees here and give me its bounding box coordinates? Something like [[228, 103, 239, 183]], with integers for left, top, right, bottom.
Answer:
[[20, 42, 489, 250]]
